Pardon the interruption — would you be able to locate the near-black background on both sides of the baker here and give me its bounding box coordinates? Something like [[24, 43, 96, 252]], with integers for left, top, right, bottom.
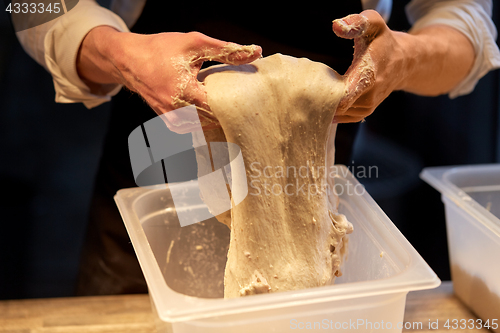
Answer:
[[0, 1, 500, 299]]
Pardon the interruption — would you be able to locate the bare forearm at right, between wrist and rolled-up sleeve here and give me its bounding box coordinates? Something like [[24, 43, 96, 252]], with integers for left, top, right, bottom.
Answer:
[[396, 25, 475, 96]]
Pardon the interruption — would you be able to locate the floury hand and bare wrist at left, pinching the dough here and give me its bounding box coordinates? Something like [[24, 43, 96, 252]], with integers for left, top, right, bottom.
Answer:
[[77, 26, 262, 128]]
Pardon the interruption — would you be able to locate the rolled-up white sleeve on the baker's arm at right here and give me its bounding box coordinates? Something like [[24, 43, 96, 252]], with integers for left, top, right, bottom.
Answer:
[[406, 0, 500, 98]]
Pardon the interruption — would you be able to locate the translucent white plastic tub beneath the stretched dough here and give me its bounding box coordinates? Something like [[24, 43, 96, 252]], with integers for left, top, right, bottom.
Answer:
[[115, 166, 440, 333]]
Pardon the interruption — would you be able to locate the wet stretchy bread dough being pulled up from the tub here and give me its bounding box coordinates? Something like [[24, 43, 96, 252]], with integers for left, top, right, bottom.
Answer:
[[200, 54, 352, 298]]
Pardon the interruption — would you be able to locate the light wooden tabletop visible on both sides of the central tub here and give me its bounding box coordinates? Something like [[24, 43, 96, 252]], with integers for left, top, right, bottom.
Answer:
[[0, 282, 488, 333]]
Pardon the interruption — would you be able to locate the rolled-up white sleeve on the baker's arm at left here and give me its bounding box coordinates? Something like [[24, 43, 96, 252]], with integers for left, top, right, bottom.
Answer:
[[17, 0, 129, 108]]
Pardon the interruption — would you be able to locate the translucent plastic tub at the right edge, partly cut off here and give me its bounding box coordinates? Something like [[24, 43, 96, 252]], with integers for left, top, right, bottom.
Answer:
[[421, 164, 500, 332]]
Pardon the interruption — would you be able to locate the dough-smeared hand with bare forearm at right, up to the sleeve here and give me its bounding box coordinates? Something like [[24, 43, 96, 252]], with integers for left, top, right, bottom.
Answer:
[[333, 10, 476, 122]]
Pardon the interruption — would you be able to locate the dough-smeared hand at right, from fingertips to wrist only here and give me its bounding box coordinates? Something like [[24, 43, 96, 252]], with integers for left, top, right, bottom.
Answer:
[[333, 10, 405, 123]]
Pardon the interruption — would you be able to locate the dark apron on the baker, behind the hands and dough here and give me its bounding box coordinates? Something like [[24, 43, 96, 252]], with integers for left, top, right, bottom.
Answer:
[[77, 0, 362, 295]]
